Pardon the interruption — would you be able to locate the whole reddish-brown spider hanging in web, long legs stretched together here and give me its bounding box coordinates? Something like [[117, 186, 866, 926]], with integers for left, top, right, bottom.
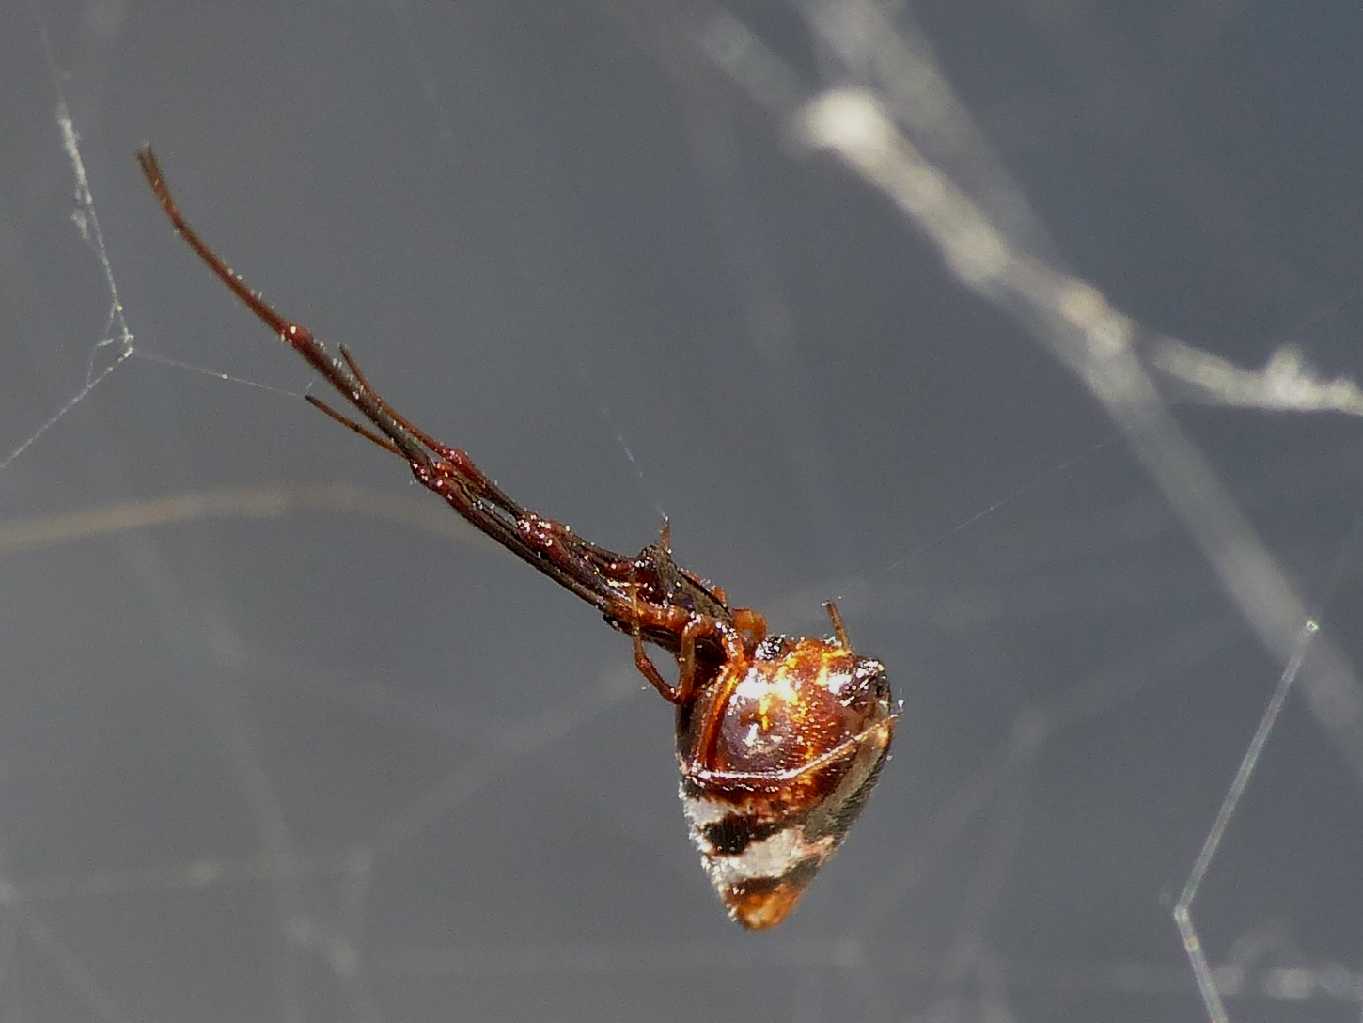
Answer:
[[138, 147, 897, 929]]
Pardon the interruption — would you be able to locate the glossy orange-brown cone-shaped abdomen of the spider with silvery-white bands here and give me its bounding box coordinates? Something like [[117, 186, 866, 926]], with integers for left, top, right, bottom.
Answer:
[[677, 636, 894, 929]]
